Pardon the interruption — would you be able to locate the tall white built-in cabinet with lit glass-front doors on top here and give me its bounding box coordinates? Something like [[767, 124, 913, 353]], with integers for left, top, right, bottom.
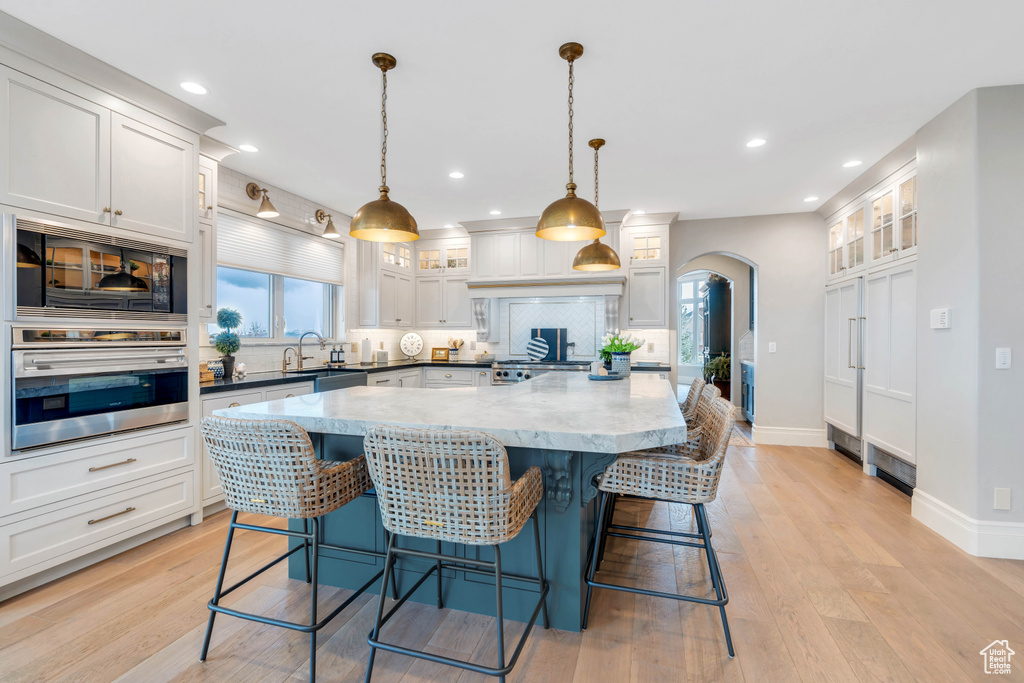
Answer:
[[823, 164, 927, 486]]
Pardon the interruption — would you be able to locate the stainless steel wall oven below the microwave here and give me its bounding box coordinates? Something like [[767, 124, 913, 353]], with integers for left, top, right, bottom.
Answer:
[[11, 326, 188, 451]]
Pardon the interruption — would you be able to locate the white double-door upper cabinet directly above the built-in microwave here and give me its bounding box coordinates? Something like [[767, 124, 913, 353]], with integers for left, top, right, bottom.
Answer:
[[0, 62, 198, 242]]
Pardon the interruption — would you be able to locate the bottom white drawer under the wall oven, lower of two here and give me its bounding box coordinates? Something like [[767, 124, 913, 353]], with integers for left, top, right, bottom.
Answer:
[[0, 473, 193, 574]]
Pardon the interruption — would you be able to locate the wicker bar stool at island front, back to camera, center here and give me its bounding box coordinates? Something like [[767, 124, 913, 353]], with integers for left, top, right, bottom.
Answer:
[[364, 425, 548, 682]]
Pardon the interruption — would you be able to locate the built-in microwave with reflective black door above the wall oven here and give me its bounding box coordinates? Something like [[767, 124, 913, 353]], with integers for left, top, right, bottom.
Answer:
[[5, 216, 187, 325]]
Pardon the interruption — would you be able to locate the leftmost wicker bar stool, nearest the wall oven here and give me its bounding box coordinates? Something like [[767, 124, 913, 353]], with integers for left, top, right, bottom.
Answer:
[[200, 418, 396, 681]]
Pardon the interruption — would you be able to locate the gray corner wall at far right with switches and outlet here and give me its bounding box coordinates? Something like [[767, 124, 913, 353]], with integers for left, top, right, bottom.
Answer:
[[918, 86, 1024, 523]]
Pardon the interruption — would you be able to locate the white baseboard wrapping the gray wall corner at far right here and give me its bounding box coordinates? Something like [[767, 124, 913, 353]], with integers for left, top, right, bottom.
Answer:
[[910, 488, 1024, 560]]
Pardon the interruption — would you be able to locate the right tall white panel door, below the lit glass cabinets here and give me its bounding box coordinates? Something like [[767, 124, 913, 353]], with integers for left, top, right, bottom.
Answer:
[[861, 263, 918, 464]]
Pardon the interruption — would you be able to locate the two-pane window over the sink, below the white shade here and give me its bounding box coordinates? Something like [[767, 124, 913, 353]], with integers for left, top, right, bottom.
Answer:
[[207, 265, 343, 340]]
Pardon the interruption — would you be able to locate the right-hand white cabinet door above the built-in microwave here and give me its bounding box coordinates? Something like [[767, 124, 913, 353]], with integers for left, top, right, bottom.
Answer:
[[111, 114, 198, 242]]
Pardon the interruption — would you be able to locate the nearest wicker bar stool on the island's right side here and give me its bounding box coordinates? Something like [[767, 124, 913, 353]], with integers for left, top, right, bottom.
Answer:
[[583, 398, 735, 657]]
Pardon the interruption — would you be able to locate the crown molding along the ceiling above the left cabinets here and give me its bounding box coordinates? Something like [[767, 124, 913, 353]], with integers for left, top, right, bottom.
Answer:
[[0, 12, 225, 133]]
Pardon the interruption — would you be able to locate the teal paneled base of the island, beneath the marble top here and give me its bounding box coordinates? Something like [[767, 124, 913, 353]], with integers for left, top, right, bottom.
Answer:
[[289, 434, 615, 632]]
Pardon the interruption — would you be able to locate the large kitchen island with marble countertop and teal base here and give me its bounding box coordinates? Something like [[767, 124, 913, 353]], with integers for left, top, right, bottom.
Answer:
[[216, 373, 686, 631]]
